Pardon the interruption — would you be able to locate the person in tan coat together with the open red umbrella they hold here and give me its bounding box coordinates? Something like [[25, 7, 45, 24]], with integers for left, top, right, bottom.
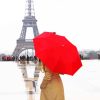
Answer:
[[33, 32, 82, 100]]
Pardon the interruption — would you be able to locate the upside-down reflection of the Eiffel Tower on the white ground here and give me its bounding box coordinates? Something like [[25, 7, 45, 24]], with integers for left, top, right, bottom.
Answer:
[[18, 56, 40, 100]]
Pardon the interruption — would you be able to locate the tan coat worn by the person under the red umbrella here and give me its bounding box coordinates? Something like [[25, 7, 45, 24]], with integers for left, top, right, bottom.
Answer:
[[40, 66, 65, 100]]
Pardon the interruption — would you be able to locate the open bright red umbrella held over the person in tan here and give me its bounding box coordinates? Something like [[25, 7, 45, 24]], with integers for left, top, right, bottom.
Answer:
[[33, 32, 82, 75]]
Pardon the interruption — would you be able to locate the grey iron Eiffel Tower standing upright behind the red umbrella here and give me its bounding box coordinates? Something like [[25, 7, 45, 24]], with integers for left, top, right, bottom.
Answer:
[[12, 0, 39, 57]]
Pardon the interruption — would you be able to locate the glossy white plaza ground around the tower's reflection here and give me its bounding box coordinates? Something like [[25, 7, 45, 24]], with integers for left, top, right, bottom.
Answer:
[[0, 60, 100, 100]]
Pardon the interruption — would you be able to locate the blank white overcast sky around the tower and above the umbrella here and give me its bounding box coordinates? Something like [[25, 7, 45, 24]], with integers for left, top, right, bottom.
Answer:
[[0, 0, 100, 53]]
